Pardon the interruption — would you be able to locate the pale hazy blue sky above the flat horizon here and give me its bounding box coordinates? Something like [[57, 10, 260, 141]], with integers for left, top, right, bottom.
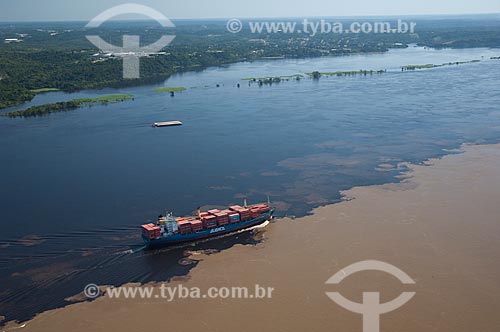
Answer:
[[0, 0, 500, 21]]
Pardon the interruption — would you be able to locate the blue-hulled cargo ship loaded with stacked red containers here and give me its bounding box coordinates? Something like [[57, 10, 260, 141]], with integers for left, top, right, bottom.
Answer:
[[141, 200, 275, 247]]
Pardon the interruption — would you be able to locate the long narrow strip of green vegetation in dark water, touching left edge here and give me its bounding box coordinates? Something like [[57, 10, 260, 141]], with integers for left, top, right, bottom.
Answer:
[[1, 94, 133, 118]]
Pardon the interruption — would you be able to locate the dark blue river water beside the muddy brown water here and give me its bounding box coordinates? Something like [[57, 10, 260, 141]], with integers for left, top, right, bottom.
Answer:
[[0, 47, 500, 319]]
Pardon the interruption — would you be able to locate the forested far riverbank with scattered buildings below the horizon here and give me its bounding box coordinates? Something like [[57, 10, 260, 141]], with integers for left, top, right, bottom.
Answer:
[[0, 16, 500, 108]]
